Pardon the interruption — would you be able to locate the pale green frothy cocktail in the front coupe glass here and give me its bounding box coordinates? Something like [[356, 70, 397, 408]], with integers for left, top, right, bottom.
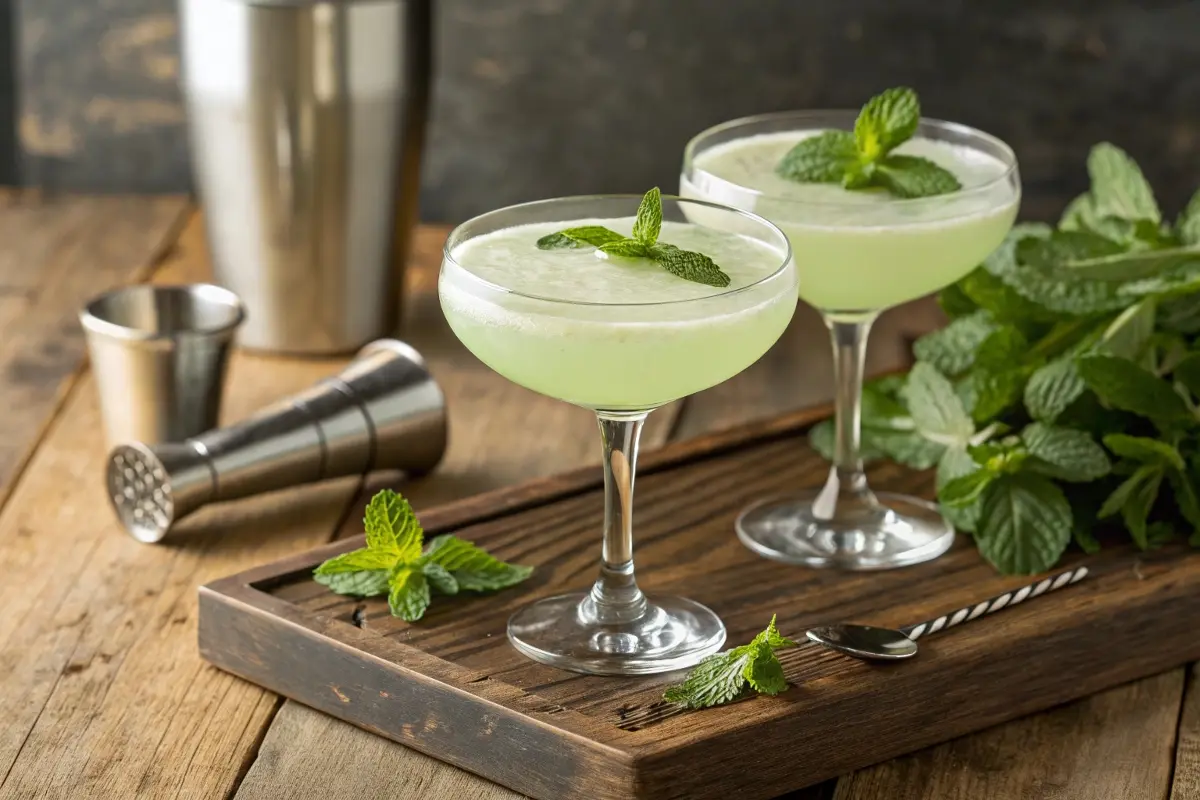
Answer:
[[439, 218, 796, 411]]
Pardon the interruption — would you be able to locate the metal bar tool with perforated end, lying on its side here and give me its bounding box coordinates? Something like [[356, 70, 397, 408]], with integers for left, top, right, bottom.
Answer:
[[107, 339, 446, 542]]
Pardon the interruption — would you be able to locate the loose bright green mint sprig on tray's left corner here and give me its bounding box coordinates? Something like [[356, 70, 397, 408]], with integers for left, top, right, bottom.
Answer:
[[313, 489, 533, 622]]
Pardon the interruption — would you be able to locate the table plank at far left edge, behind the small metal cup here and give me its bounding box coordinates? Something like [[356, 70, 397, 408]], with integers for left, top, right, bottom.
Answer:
[[0, 190, 187, 504]]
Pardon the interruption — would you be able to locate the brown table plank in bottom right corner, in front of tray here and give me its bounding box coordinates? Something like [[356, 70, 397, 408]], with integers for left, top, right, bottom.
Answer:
[[834, 669, 1187, 800]]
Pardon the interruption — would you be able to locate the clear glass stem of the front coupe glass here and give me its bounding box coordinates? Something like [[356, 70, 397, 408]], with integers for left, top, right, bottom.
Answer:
[[588, 411, 648, 624]]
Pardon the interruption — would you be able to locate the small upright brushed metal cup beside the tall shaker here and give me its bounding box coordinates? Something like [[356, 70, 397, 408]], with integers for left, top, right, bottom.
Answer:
[[79, 283, 246, 447]]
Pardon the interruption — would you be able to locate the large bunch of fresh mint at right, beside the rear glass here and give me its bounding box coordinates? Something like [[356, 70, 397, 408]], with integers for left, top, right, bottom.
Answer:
[[811, 144, 1200, 573]]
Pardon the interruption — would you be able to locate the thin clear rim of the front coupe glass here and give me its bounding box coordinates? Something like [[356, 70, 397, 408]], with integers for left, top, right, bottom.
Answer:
[[442, 193, 792, 308]]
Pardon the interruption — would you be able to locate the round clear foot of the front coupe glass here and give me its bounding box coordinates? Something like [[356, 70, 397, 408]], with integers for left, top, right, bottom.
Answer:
[[509, 593, 725, 675]]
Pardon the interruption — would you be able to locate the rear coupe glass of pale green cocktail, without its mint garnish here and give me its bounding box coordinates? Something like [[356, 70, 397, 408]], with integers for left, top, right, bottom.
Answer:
[[680, 110, 1020, 570]]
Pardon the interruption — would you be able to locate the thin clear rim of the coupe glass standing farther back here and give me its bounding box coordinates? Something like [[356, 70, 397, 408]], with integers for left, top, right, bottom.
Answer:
[[683, 108, 1018, 209]]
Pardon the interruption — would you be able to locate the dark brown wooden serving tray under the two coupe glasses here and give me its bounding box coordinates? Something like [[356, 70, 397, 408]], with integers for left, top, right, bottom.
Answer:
[[199, 409, 1200, 800]]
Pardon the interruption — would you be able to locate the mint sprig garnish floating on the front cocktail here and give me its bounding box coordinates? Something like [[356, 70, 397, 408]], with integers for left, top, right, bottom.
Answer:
[[538, 186, 730, 288]]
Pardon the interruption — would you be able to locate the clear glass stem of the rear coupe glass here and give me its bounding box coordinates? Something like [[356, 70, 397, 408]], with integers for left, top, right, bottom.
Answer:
[[812, 314, 876, 519]]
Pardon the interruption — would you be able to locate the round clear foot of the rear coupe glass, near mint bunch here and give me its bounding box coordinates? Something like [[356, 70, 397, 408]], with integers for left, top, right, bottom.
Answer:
[[737, 489, 954, 570]]
